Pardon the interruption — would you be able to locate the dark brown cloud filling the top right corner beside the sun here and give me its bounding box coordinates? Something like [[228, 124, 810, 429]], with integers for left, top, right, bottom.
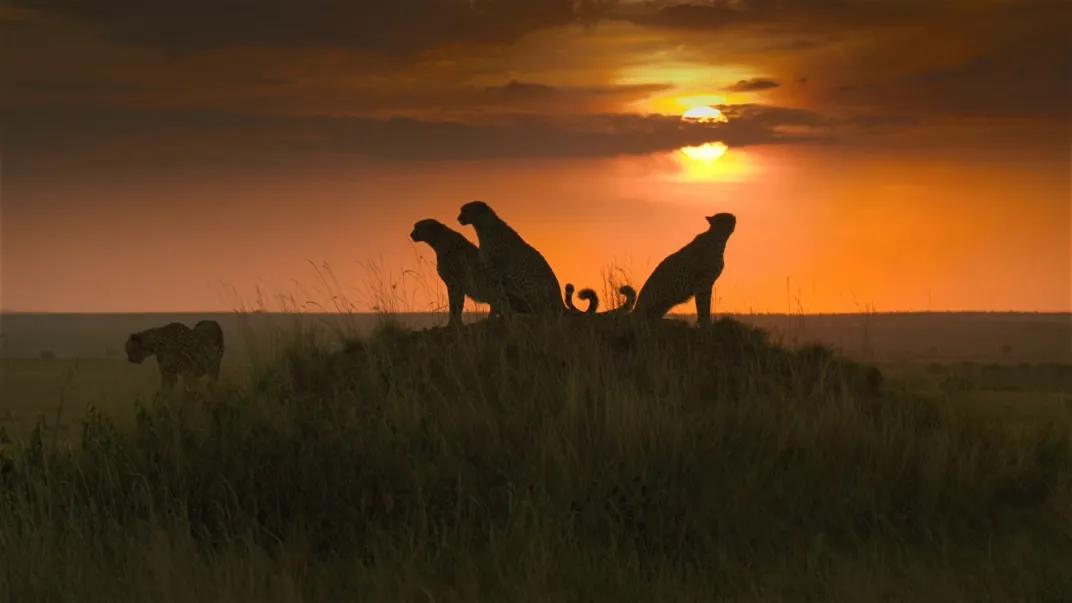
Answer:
[[631, 0, 1072, 122]]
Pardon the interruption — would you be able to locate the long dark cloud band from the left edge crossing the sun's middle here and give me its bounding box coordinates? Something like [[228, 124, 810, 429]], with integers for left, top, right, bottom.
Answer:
[[0, 105, 824, 170]]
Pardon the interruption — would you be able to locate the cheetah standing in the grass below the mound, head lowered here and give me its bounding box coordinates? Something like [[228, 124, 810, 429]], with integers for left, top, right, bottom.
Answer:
[[126, 321, 223, 388]]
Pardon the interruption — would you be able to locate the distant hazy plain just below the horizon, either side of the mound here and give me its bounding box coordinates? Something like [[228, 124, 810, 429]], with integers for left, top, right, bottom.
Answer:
[[0, 312, 1072, 364]]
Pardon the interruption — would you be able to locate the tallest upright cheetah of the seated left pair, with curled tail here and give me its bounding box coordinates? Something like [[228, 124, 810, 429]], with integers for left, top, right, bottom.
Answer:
[[458, 201, 598, 315]]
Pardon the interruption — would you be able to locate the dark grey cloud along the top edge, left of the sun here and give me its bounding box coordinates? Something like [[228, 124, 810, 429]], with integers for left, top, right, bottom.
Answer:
[[12, 0, 601, 54]]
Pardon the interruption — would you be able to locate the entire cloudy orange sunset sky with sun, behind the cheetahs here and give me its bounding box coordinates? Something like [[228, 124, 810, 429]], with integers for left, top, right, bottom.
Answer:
[[0, 0, 1072, 312]]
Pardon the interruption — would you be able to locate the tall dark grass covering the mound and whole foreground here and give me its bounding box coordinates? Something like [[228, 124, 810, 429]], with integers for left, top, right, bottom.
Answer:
[[0, 320, 1072, 601]]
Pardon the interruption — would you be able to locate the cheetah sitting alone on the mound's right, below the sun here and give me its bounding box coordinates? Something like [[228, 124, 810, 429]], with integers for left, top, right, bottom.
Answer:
[[632, 214, 736, 325]]
